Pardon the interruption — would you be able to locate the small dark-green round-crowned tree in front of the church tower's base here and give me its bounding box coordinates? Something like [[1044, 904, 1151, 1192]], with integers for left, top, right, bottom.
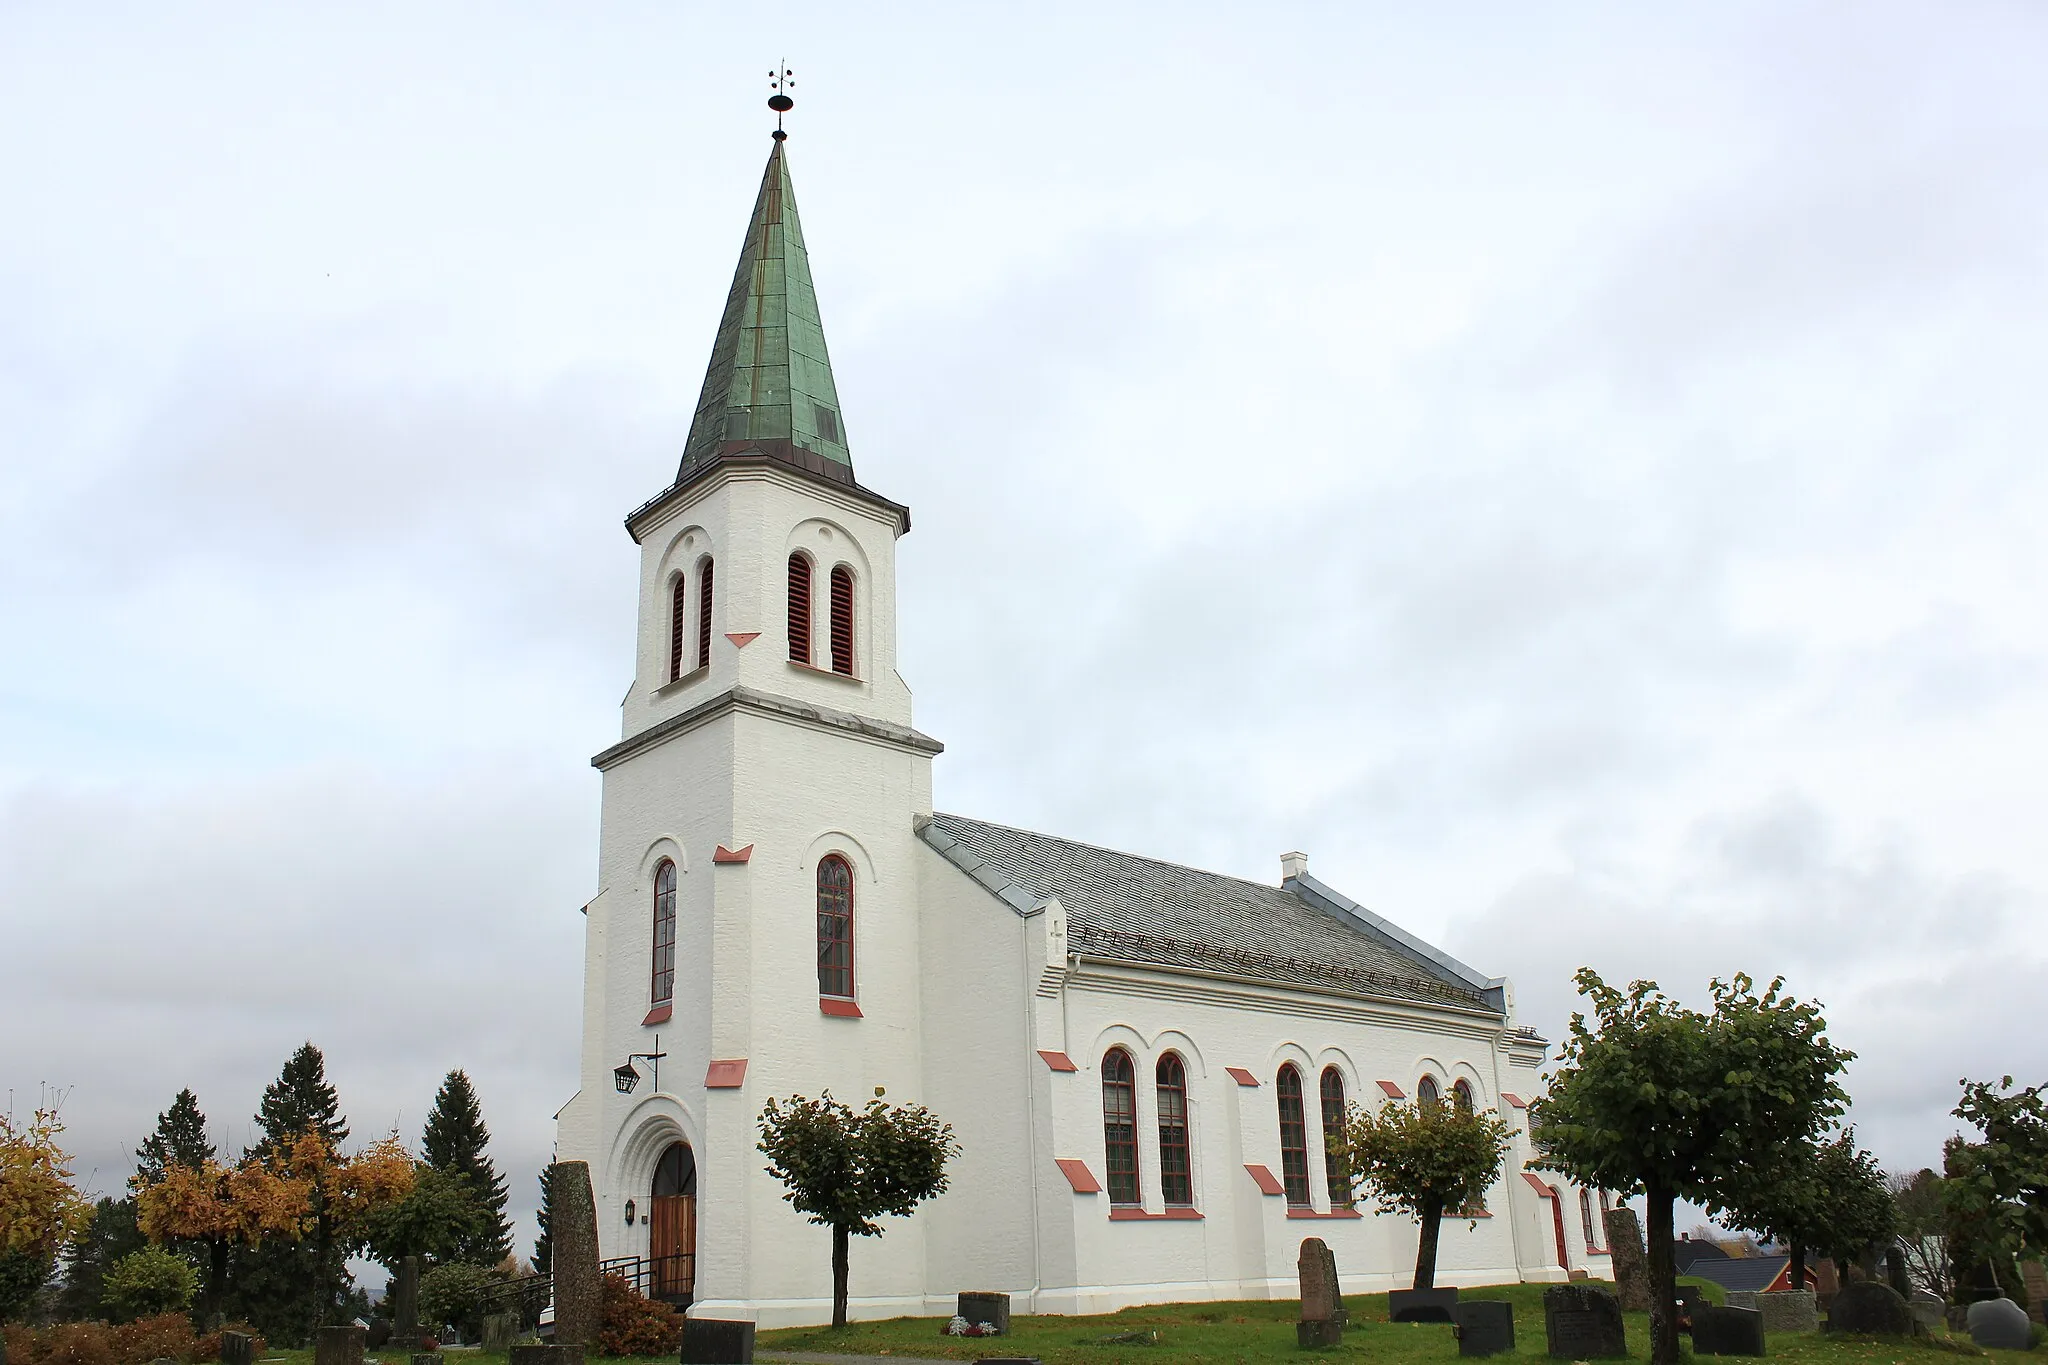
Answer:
[[760, 1085, 961, 1328]]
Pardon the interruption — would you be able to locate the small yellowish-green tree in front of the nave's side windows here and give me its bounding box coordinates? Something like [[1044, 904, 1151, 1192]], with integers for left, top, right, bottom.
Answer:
[[1331, 1099, 1513, 1289]]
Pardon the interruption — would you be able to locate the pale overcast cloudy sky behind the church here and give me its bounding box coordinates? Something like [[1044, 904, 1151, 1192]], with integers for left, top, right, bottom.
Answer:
[[0, 0, 2048, 1268]]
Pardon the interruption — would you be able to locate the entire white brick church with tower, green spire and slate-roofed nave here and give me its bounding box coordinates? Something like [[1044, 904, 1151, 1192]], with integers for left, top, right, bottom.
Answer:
[[557, 127, 1608, 1326]]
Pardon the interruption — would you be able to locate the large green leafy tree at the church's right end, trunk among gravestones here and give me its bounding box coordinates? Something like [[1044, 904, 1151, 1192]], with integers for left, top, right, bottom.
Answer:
[[1532, 968, 1853, 1365]]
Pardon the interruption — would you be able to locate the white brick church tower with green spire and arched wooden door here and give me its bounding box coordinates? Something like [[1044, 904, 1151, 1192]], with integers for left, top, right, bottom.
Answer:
[[559, 129, 940, 1316]]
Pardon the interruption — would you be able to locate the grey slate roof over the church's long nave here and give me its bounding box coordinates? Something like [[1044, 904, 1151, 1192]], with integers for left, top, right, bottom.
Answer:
[[920, 812, 1499, 1013]]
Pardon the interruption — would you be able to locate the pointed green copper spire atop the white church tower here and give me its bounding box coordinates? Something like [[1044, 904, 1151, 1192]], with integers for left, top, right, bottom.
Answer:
[[676, 135, 854, 483]]
